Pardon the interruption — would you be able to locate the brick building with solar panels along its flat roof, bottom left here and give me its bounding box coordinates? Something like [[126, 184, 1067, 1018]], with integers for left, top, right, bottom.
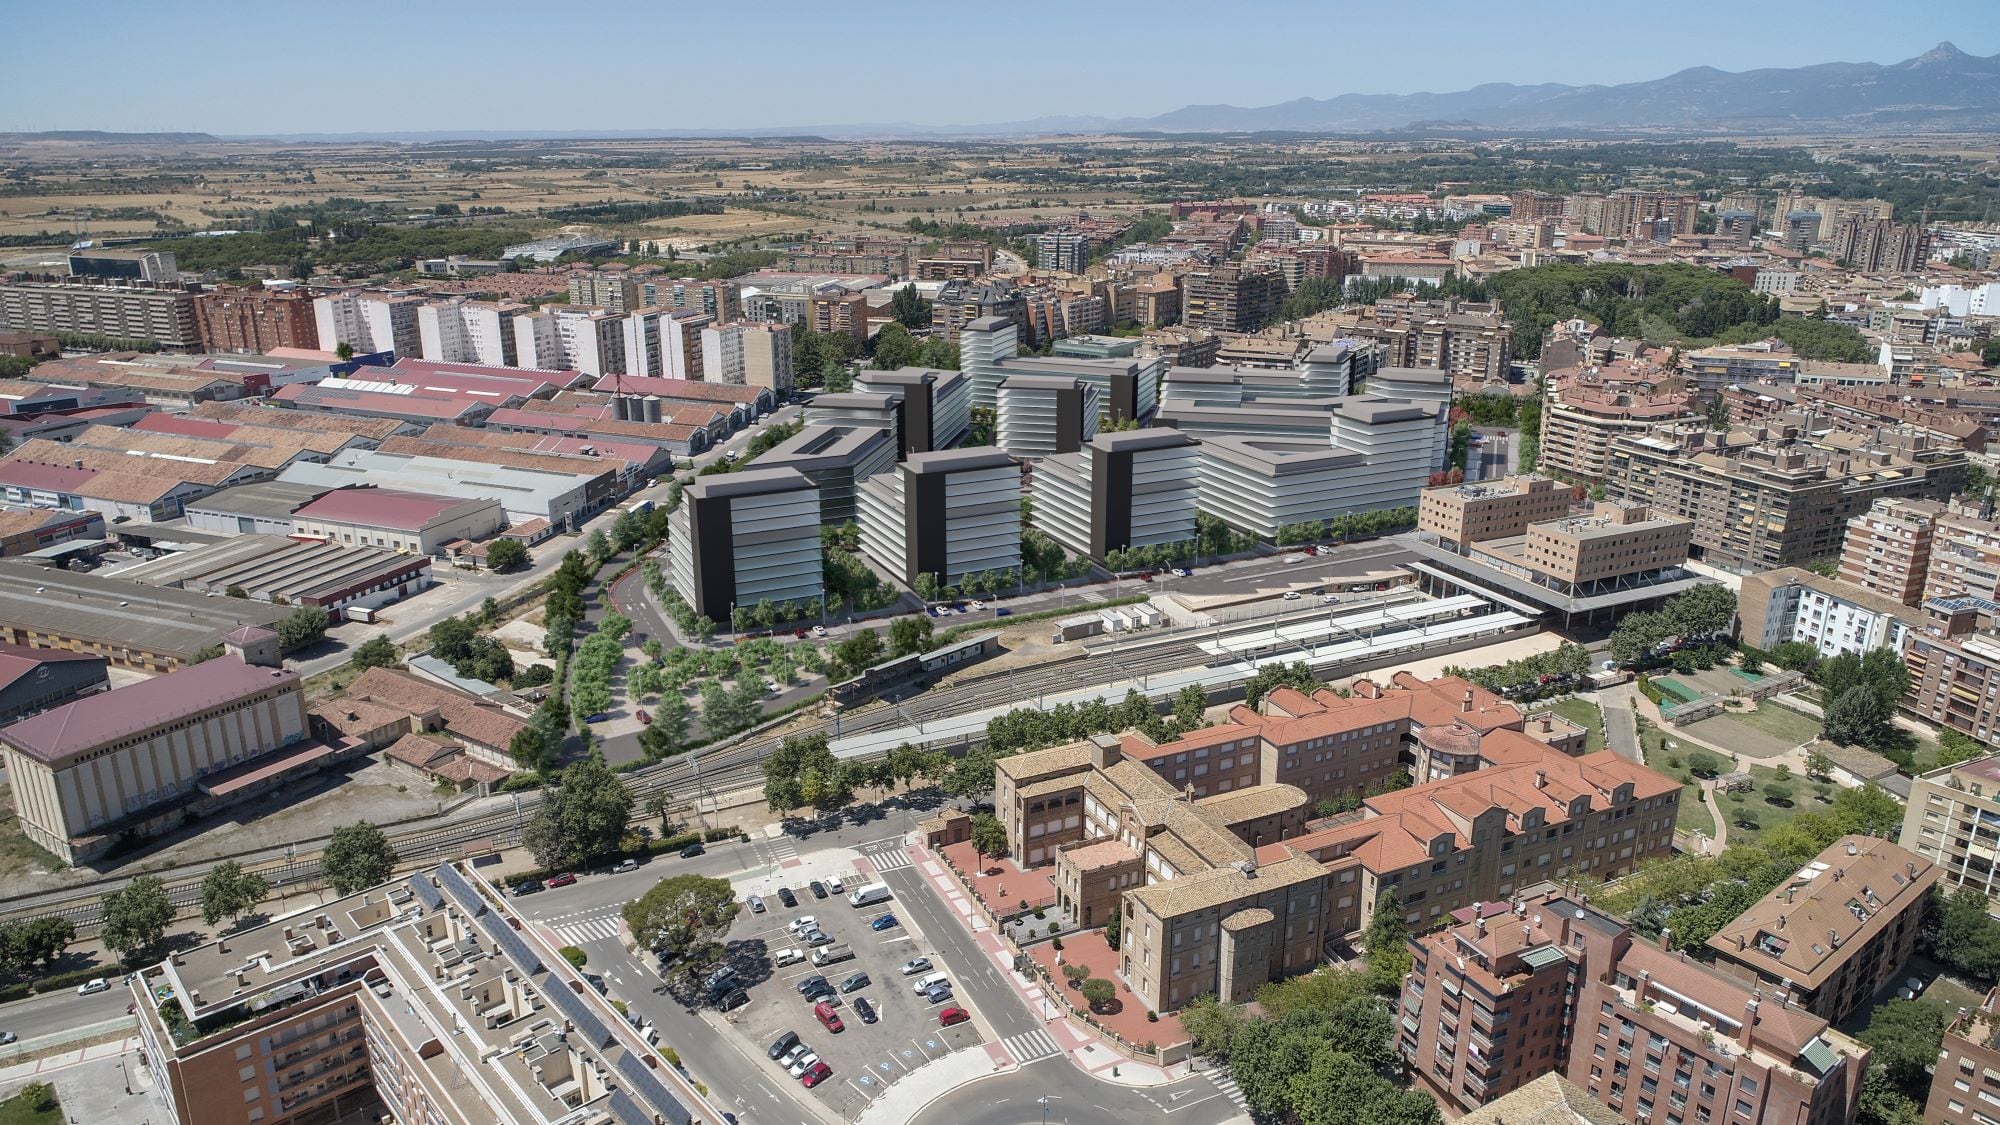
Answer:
[[130, 865, 724, 1125]]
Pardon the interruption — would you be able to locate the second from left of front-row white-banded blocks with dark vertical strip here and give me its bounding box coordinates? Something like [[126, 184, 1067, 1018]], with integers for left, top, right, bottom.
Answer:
[[860, 446, 1020, 587]]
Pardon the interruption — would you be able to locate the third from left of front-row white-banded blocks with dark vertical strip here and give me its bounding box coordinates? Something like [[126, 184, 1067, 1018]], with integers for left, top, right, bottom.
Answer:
[[1030, 430, 1200, 560]]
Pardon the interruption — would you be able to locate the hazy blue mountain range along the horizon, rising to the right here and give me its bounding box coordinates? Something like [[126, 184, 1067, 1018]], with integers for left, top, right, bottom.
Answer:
[[0, 42, 2000, 144]]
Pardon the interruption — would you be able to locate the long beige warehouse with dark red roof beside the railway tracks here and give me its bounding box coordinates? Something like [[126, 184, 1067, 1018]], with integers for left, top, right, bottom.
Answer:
[[0, 657, 312, 863]]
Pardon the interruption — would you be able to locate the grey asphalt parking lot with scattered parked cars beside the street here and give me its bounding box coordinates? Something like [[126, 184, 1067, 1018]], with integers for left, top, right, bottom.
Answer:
[[728, 856, 984, 1115]]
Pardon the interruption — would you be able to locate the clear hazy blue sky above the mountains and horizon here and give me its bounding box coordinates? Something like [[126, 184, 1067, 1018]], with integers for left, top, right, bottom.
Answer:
[[0, 0, 2000, 134]]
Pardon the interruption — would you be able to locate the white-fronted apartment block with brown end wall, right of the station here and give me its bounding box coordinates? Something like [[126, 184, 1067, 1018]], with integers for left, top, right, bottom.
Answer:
[[1736, 567, 1928, 657]]
